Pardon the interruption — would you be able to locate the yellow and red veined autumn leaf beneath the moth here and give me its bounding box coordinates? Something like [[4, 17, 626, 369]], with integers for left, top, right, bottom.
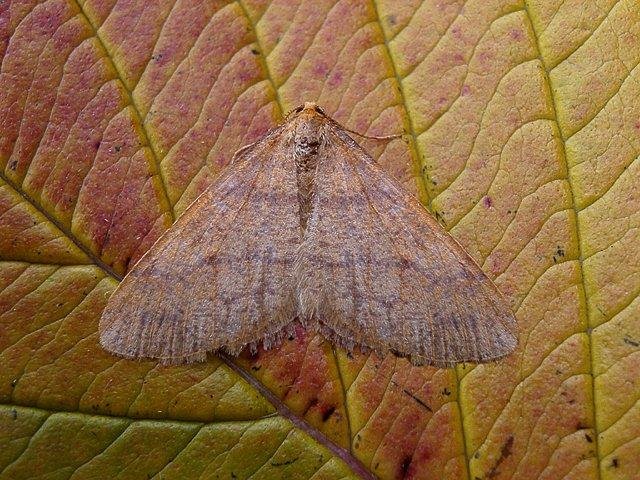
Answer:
[[0, 0, 640, 480]]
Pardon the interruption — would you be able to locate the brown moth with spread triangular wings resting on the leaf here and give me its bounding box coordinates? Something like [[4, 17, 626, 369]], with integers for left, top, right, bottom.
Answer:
[[100, 103, 517, 367]]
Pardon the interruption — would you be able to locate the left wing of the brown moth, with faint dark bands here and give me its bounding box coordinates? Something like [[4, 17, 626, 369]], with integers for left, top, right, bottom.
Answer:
[[100, 131, 300, 363]]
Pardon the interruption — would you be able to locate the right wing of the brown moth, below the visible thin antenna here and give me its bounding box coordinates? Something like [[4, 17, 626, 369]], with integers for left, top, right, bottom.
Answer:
[[297, 131, 517, 367]]
